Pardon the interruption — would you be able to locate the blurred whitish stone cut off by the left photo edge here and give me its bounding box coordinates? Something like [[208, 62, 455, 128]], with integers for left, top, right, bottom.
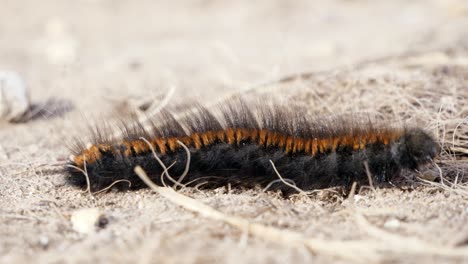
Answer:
[[0, 71, 29, 121]]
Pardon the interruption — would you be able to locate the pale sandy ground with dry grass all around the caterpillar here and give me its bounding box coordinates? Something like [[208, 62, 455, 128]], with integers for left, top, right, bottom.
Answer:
[[0, 0, 468, 263]]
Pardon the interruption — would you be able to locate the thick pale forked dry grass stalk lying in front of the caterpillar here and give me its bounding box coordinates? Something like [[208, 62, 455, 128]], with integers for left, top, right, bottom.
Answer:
[[135, 163, 468, 263]]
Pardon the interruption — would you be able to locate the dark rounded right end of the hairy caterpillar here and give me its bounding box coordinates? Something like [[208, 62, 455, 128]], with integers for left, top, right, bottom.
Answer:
[[394, 128, 440, 170]]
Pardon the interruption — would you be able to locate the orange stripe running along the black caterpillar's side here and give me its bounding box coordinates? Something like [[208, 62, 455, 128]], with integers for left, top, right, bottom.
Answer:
[[71, 128, 408, 164]]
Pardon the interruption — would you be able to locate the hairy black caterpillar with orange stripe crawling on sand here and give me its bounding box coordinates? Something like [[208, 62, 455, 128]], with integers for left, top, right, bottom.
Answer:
[[66, 100, 439, 192]]
